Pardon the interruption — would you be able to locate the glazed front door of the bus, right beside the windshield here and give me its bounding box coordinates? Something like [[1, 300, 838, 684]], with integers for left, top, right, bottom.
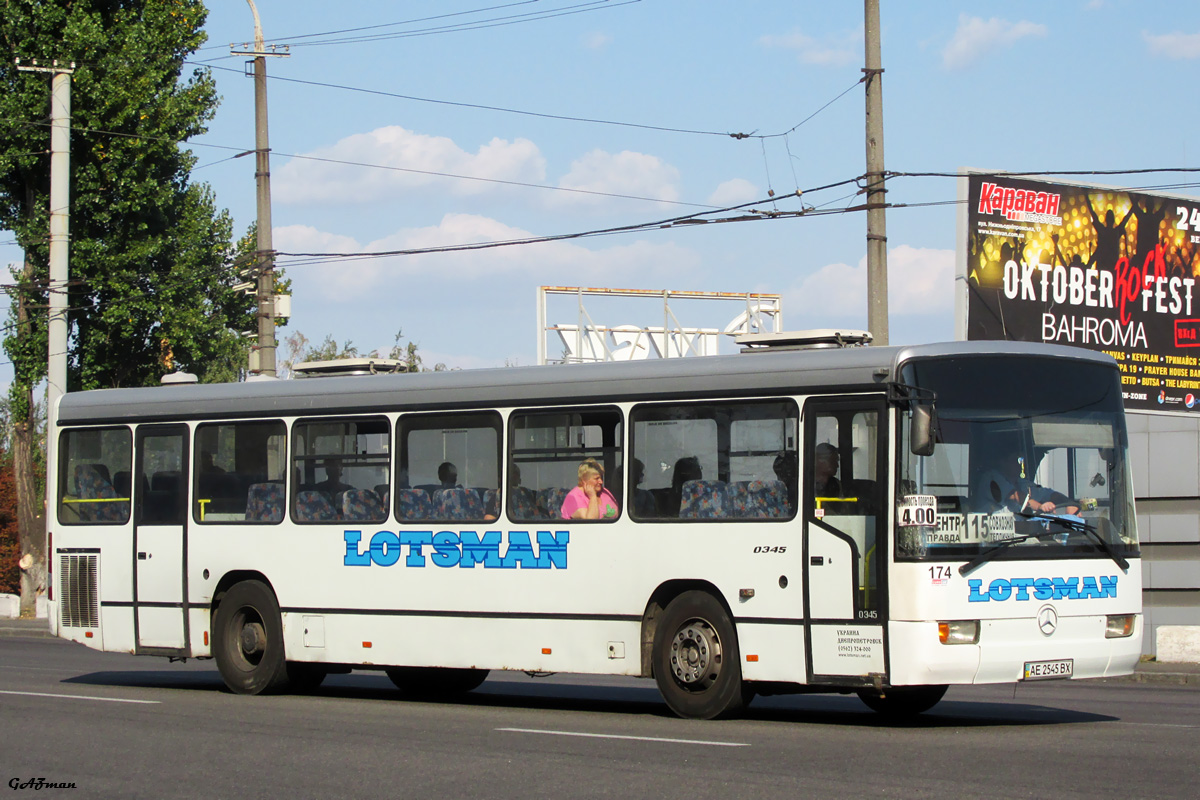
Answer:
[[800, 398, 888, 685]]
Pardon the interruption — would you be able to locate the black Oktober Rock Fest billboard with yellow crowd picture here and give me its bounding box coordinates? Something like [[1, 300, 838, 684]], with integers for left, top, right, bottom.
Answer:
[[959, 173, 1200, 414]]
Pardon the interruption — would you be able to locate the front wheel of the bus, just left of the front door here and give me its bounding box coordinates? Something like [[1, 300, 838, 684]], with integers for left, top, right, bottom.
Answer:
[[653, 591, 754, 720]]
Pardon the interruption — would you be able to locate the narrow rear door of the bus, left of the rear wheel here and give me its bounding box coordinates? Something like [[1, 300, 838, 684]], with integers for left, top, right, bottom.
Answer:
[[133, 425, 187, 655]]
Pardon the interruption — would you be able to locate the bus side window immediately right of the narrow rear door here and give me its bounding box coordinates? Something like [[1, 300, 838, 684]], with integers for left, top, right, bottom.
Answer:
[[192, 420, 287, 524]]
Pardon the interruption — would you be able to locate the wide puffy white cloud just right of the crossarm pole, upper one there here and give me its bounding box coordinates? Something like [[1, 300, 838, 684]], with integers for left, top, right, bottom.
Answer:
[[274, 126, 546, 205]]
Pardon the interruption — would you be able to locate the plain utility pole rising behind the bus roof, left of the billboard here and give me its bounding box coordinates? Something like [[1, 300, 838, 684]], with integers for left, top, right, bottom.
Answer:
[[863, 0, 888, 345]]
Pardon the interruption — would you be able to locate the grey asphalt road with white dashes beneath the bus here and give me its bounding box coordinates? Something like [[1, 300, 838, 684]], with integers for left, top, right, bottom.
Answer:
[[0, 638, 1200, 800]]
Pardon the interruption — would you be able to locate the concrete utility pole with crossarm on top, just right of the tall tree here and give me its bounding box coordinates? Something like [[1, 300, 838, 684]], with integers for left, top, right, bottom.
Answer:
[[230, 0, 289, 378]]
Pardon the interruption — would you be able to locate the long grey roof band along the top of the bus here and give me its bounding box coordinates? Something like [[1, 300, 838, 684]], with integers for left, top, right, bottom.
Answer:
[[58, 342, 1116, 425]]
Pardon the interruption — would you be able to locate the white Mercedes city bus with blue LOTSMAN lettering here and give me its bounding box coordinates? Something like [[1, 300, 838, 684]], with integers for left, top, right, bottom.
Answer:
[[42, 342, 1142, 717]]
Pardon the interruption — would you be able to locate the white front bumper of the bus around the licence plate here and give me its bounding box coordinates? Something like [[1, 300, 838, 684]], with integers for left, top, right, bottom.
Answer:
[[888, 614, 1142, 686]]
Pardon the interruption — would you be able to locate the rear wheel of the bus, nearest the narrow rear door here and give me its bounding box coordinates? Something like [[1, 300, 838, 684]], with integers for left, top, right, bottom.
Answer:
[[212, 581, 288, 694]]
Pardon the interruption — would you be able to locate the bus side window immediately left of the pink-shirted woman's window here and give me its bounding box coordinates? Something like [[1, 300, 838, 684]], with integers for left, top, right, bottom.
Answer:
[[396, 411, 500, 522]]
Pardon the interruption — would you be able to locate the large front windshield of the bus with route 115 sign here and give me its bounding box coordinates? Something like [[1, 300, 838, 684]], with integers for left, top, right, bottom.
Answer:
[[896, 355, 1138, 560]]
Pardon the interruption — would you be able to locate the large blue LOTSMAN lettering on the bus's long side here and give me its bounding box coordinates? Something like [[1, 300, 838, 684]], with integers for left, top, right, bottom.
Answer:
[[342, 530, 571, 570]]
